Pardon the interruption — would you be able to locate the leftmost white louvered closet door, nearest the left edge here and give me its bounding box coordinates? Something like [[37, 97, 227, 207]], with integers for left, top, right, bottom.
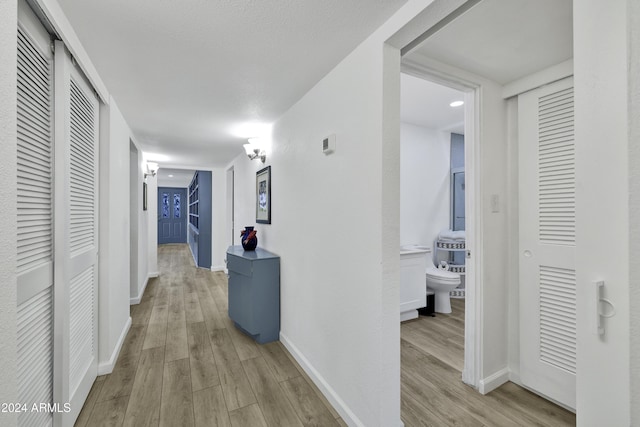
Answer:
[[16, 2, 53, 427]]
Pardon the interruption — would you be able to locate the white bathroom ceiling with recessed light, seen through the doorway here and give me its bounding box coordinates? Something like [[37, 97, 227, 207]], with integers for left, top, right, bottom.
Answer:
[[400, 74, 464, 134]]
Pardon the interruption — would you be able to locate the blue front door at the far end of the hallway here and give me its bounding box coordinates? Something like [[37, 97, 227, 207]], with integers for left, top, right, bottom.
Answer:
[[158, 187, 188, 244]]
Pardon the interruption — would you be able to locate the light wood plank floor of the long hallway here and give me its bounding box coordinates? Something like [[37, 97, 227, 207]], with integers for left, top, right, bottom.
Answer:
[[75, 245, 346, 427]]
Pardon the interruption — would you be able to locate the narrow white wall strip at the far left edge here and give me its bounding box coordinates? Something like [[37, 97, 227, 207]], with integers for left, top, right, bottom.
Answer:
[[0, 0, 18, 427]]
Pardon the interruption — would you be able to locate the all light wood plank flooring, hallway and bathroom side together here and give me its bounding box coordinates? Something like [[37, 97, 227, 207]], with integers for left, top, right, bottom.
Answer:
[[76, 245, 575, 427]]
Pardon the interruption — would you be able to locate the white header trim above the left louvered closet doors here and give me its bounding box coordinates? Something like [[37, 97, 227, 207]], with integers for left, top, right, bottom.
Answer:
[[35, 0, 109, 105]]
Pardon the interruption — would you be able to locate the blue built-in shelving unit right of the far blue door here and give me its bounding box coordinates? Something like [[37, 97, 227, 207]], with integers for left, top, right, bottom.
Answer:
[[187, 171, 211, 268]]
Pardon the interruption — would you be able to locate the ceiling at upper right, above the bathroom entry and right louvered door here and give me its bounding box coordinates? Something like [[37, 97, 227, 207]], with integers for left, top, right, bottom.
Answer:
[[408, 0, 578, 84]]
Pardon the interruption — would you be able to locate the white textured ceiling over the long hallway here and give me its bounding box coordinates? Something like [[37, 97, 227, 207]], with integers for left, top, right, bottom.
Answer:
[[59, 0, 406, 168]]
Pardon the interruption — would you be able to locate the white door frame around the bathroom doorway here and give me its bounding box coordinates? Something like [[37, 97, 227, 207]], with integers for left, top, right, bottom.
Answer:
[[401, 59, 482, 394]]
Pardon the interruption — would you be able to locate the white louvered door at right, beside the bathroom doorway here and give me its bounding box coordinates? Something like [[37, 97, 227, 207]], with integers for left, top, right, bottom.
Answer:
[[518, 78, 576, 408]]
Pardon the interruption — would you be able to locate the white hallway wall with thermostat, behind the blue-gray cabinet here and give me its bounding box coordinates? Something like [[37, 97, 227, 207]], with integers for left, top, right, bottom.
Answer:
[[228, 25, 400, 426]]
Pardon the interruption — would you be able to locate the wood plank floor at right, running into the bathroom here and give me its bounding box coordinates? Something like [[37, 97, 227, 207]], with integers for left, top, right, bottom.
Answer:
[[400, 298, 576, 427]]
